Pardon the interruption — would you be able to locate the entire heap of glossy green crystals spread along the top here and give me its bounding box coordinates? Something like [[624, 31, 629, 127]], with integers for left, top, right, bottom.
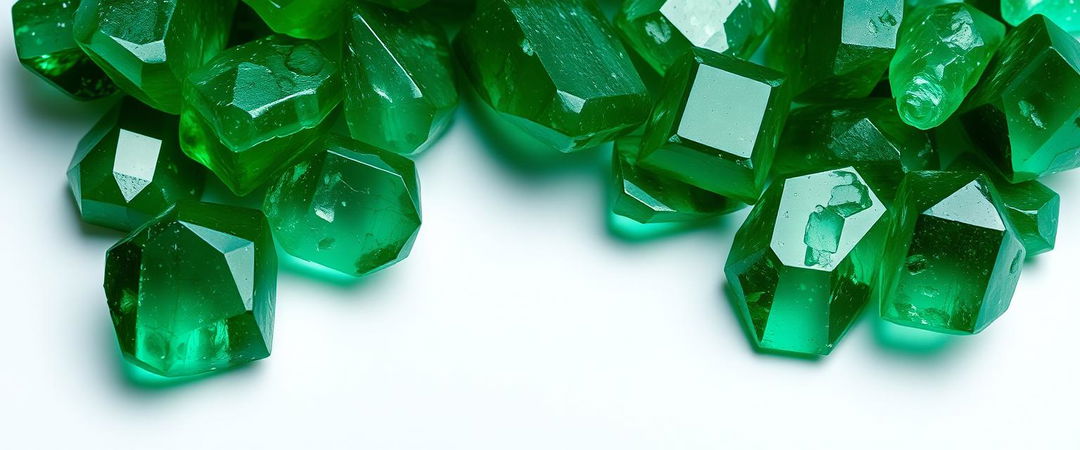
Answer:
[[13, 0, 1080, 377]]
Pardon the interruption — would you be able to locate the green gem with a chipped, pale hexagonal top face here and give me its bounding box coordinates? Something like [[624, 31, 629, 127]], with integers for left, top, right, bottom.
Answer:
[[725, 167, 887, 355]]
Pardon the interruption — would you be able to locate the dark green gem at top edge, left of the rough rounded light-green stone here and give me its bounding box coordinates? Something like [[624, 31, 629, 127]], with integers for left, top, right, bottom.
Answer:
[[770, 0, 904, 101]]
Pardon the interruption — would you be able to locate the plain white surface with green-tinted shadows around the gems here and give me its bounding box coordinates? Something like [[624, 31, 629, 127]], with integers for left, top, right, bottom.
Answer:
[[0, 2, 1080, 450]]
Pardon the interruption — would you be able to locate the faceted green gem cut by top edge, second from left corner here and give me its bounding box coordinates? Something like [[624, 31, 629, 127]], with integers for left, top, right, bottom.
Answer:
[[75, 0, 237, 114]]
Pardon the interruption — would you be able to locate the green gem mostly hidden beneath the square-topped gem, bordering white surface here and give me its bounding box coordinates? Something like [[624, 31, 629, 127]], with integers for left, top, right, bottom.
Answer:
[[611, 135, 743, 223]]
